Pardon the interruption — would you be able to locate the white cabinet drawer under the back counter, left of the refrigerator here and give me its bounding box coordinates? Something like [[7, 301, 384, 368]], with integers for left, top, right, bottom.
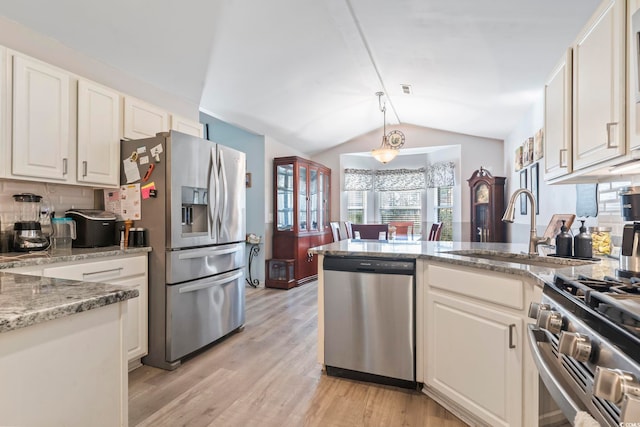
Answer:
[[43, 256, 147, 282]]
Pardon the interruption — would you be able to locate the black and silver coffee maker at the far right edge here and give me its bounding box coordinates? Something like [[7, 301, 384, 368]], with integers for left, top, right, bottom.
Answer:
[[618, 187, 640, 277]]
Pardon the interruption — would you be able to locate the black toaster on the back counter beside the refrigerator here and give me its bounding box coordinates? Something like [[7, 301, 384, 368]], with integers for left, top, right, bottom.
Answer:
[[65, 209, 116, 248]]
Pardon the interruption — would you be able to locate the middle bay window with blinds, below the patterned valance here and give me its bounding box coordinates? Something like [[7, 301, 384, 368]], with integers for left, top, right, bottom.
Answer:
[[378, 190, 423, 234]]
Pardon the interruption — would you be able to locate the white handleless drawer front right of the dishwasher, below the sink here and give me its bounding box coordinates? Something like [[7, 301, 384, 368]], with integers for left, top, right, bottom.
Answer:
[[427, 265, 524, 310]]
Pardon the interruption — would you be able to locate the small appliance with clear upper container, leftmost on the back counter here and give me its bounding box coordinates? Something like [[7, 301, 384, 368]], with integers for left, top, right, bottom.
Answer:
[[13, 193, 49, 252]]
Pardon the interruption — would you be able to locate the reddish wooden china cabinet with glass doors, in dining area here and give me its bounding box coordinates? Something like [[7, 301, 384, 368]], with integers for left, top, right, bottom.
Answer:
[[265, 157, 332, 289]]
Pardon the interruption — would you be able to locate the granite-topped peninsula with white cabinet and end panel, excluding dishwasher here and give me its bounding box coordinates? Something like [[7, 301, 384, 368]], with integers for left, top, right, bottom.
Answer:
[[309, 240, 617, 426]]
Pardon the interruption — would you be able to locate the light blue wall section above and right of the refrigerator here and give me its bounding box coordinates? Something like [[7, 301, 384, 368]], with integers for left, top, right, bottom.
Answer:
[[200, 112, 266, 283]]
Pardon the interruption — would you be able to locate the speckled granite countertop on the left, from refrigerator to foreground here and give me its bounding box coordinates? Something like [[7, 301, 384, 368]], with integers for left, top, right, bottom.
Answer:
[[0, 246, 151, 333]]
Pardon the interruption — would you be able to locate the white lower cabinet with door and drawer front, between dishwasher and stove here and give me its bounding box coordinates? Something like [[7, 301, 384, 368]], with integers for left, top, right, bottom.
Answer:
[[423, 265, 538, 426]]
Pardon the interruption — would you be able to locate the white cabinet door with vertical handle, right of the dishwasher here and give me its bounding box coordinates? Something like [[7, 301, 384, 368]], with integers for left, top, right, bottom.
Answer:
[[424, 290, 524, 426]]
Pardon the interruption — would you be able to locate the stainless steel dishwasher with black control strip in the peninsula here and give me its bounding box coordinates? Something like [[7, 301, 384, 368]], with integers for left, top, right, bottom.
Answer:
[[323, 256, 416, 388]]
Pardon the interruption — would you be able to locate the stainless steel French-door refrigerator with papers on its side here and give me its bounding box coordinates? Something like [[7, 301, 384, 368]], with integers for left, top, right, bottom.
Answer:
[[120, 131, 246, 369]]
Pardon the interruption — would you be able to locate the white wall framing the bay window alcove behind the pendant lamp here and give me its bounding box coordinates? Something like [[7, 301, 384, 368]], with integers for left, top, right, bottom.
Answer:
[[313, 125, 504, 240]]
